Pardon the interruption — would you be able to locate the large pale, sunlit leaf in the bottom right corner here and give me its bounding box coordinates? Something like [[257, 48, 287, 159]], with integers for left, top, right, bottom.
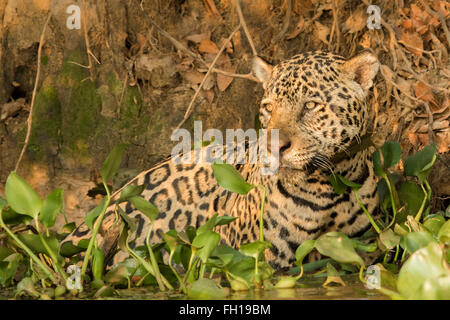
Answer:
[[397, 242, 450, 299]]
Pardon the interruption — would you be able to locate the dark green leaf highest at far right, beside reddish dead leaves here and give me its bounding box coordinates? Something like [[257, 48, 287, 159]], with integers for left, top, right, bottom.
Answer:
[[403, 144, 437, 182]]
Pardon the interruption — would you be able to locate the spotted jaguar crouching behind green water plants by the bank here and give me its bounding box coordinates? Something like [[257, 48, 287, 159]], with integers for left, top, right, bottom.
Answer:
[[62, 51, 380, 269]]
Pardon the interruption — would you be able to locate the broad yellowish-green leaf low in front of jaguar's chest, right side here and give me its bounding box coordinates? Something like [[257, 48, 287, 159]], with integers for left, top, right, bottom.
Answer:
[[315, 232, 364, 267]]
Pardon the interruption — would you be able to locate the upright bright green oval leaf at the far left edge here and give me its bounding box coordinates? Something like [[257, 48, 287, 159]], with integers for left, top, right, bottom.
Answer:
[[5, 172, 42, 219]]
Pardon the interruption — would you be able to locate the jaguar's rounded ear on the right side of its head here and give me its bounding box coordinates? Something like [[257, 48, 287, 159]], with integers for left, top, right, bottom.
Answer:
[[343, 52, 380, 92]]
